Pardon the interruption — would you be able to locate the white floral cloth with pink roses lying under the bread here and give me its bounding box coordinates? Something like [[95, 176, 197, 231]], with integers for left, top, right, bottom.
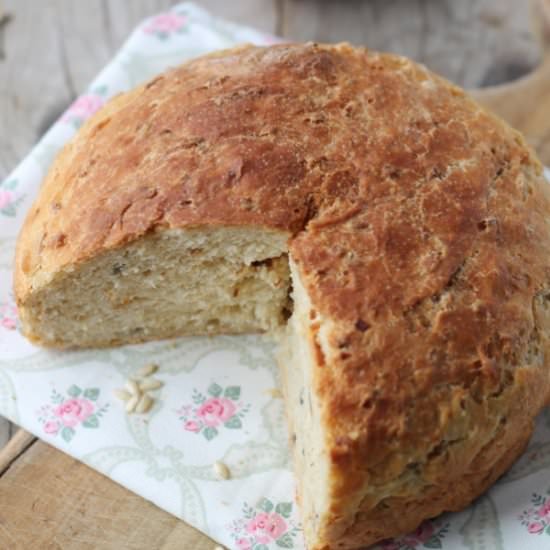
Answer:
[[0, 3, 550, 550]]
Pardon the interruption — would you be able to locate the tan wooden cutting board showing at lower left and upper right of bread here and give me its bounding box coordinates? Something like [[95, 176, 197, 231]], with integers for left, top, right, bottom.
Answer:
[[0, 0, 550, 550]]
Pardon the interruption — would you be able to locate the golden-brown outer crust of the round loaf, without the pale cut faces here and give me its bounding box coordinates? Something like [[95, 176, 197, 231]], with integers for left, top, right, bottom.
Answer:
[[15, 44, 550, 548]]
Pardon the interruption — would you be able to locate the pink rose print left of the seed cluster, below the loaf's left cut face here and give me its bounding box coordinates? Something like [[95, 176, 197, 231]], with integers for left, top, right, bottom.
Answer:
[[37, 385, 109, 443]]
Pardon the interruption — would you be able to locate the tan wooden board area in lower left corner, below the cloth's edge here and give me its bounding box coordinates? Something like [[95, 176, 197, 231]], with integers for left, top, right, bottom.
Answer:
[[0, 430, 215, 550]]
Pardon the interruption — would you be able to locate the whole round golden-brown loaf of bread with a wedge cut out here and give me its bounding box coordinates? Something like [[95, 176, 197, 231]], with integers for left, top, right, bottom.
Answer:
[[15, 44, 550, 550]]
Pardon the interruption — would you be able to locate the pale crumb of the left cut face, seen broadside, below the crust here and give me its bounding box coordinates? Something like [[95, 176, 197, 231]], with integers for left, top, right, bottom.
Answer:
[[17, 227, 289, 347]]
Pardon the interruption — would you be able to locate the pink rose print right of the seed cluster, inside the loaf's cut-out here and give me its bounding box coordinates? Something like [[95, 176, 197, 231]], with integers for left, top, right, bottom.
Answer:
[[176, 383, 250, 441]]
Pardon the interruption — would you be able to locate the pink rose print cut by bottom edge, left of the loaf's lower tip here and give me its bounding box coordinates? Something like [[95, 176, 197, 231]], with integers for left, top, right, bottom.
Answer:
[[227, 498, 300, 550]]
